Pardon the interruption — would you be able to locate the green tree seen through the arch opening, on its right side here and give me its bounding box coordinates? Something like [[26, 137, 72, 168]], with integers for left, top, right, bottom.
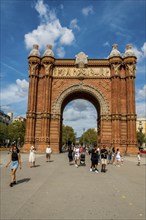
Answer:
[[79, 128, 97, 145]]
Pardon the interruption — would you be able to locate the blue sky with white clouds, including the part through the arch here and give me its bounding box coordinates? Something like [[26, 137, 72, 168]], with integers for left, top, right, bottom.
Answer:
[[0, 0, 146, 136]]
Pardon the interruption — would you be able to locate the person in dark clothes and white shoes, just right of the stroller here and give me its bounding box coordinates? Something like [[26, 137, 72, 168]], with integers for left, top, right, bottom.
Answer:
[[90, 147, 98, 173]]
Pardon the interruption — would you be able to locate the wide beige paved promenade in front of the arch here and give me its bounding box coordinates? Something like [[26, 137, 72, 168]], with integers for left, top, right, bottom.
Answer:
[[0, 152, 146, 220]]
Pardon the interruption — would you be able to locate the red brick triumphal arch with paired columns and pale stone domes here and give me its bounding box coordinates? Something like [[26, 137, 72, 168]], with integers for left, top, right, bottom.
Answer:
[[23, 44, 137, 154]]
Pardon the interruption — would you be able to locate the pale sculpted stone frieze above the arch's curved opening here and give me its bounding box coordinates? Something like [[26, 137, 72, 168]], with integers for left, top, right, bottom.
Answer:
[[53, 67, 110, 78]]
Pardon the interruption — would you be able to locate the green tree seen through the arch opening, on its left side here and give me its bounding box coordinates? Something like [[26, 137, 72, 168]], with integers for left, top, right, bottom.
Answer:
[[62, 125, 76, 145]]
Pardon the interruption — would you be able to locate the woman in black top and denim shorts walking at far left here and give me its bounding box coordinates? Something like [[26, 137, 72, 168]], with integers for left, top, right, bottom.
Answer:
[[6, 146, 21, 187]]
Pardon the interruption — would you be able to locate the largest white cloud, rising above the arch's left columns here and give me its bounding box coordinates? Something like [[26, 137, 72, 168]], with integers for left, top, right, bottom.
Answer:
[[24, 0, 75, 54]]
